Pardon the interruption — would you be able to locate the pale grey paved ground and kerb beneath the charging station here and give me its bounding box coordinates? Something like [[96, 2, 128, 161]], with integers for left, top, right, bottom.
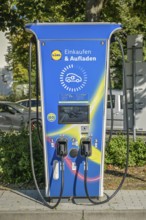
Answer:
[[0, 189, 146, 220]]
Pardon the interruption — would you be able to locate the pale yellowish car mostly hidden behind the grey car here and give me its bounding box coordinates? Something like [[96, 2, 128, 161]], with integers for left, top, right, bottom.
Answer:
[[16, 99, 41, 112]]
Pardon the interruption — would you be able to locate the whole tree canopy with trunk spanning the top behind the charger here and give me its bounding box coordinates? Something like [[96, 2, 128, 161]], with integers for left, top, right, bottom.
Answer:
[[0, 0, 146, 89]]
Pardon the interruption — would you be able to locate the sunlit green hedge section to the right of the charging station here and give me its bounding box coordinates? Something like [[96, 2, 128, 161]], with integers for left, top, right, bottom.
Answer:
[[105, 135, 146, 168]]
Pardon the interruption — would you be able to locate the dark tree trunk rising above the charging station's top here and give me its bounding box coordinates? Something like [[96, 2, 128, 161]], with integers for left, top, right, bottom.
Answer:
[[86, 0, 105, 22]]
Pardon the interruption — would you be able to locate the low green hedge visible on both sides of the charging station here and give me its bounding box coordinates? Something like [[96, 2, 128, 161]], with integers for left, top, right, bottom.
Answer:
[[0, 130, 146, 184]]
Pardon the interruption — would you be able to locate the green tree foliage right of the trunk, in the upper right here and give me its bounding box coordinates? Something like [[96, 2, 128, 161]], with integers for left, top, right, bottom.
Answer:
[[99, 0, 146, 89]]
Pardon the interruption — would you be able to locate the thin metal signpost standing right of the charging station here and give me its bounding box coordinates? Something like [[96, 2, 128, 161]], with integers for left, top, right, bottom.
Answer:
[[132, 46, 136, 141]]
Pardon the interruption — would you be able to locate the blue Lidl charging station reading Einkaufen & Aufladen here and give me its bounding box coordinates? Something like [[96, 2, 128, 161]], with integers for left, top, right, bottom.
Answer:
[[26, 23, 121, 198]]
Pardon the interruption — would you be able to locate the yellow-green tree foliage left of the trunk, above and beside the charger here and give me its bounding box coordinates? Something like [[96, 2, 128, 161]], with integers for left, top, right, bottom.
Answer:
[[0, 0, 85, 83]]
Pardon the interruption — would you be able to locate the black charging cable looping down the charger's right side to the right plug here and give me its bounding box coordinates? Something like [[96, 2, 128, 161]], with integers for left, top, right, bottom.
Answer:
[[84, 37, 129, 205]]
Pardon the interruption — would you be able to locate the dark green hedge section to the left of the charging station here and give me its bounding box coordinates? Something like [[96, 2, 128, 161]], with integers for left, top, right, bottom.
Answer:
[[0, 130, 44, 184]]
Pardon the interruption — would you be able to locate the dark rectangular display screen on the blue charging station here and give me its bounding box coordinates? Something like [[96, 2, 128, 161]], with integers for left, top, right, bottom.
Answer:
[[58, 105, 90, 124]]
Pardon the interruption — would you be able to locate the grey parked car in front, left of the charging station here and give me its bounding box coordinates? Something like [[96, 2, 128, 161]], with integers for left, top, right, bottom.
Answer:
[[0, 101, 41, 131]]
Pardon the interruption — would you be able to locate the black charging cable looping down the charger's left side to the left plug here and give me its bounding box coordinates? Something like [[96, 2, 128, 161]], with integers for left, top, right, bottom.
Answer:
[[28, 38, 64, 209]]
